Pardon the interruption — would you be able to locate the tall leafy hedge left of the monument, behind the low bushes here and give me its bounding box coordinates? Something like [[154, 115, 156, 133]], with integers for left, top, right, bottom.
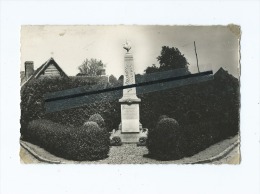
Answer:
[[20, 77, 122, 138]]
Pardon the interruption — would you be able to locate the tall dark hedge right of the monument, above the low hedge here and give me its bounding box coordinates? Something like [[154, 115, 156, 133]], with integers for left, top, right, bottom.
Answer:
[[139, 68, 240, 132]]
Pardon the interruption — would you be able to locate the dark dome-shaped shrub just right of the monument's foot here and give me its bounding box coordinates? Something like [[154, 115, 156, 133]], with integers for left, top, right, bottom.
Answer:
[[146, 118, 184, 160]]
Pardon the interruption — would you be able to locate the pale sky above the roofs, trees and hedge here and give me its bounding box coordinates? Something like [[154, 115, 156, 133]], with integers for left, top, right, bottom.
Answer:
[[21, 25, 240, 78]]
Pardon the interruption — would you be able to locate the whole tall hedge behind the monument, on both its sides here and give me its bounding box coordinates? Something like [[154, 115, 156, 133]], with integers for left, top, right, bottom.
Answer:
[[21, 69, 240, 134]]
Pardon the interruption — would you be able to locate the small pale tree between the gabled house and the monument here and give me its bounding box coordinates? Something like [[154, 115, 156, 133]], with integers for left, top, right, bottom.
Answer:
[[77, 58, 104, 76]]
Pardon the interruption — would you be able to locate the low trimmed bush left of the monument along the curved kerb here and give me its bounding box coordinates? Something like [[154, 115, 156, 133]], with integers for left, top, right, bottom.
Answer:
[[26, 119, 109, 161]]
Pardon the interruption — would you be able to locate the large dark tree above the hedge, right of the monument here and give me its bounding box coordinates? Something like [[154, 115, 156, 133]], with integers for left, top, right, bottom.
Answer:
[[145, 46, 189, 73]]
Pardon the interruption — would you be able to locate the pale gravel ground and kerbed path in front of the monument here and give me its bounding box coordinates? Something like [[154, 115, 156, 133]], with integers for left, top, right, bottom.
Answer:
[[20, 136, 240, 164]]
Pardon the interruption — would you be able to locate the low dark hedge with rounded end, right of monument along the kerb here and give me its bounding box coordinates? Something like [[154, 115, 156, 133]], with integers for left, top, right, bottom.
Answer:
[[146, 118, 238, 160]]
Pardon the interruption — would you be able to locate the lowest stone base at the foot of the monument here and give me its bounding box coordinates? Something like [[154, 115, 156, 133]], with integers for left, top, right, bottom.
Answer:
[[110, 129, 148, 143]]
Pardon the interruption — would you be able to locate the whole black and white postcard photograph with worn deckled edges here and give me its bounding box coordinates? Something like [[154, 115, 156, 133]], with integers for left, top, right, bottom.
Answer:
[[20, 24, 241, 164]]
